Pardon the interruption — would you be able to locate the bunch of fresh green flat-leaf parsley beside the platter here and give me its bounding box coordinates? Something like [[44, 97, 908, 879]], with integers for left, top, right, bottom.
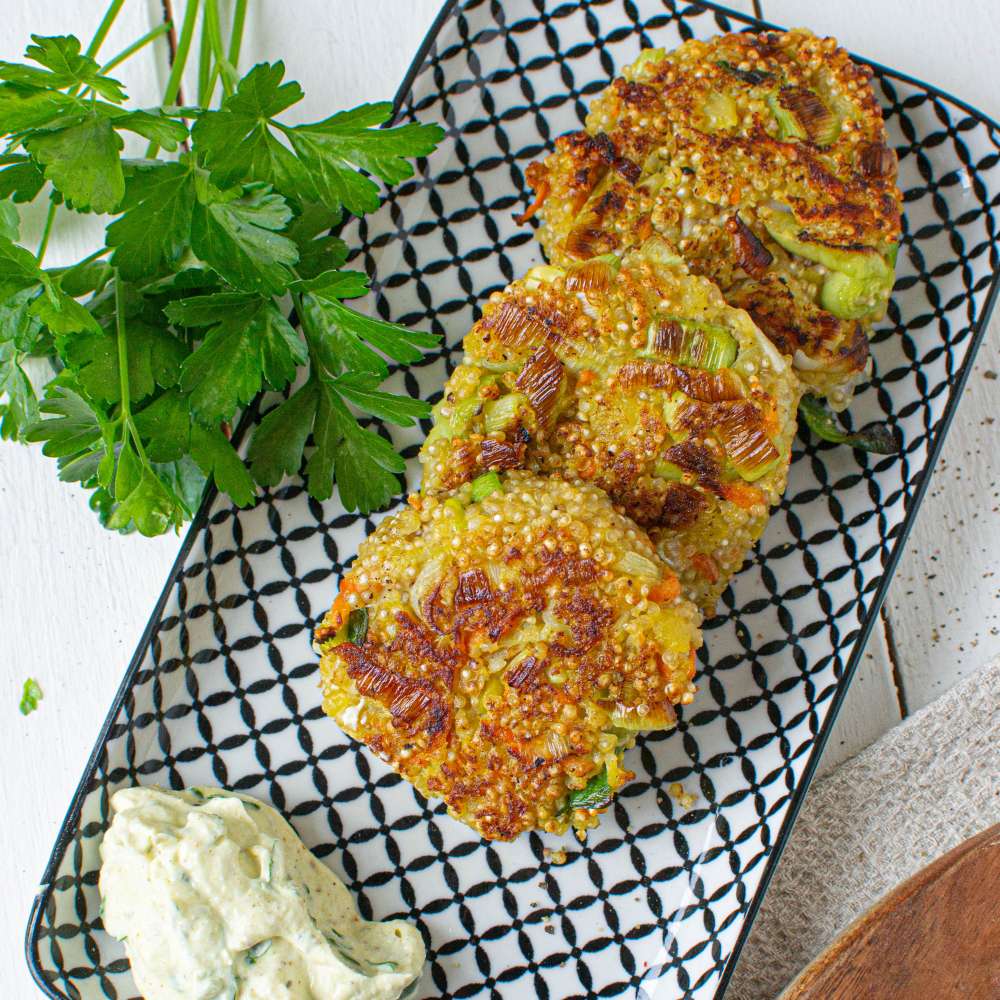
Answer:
[[0, 0, 443, 535]]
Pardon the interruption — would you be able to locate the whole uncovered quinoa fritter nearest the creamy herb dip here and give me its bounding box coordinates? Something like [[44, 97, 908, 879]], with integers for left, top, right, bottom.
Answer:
[[315, 472, 701, 840]]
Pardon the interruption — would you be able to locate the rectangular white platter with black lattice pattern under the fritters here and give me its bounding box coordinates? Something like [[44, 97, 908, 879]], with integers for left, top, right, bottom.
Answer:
[[27, 0, 1000, 1000]]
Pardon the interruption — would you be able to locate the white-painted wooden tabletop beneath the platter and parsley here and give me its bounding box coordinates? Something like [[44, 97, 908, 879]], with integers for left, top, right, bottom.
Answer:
[[0, 0, 1000, 1000]]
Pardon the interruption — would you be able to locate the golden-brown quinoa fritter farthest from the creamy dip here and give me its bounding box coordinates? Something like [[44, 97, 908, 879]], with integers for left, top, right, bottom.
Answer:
[[526, 30, 902, 408]]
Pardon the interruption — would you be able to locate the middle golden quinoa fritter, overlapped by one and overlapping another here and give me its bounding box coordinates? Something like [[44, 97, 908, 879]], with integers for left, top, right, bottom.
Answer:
[[420, 237, 798, 610]]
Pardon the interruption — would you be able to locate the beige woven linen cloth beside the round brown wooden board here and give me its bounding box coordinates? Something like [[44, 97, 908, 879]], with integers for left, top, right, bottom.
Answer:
[[726, 660, 1000, 1000]]
